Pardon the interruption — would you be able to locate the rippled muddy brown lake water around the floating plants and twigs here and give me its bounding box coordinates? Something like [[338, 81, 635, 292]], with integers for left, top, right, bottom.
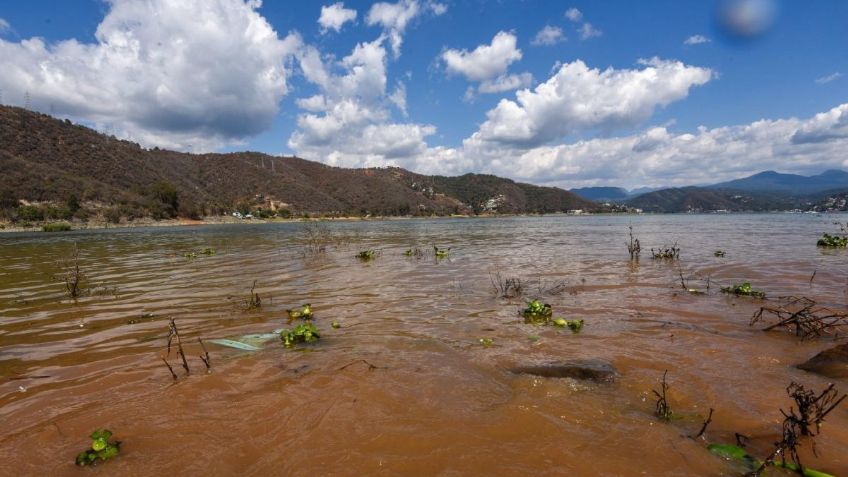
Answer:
[[0, 214, 848, 476]]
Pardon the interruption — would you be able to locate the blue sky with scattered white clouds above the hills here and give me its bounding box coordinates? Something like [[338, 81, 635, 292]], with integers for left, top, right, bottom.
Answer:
[[0, 0, 848, 188]]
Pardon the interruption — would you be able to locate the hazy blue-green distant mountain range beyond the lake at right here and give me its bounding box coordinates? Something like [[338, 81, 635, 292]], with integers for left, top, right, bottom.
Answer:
[[571, 169, 848, 213]]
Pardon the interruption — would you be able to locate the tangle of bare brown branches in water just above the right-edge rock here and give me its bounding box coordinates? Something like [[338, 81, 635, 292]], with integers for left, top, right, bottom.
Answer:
[[749, 297, 848, 340]]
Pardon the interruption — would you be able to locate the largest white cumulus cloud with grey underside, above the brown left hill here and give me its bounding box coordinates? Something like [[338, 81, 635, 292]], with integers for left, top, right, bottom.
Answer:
[[0, 0, 301, 150]]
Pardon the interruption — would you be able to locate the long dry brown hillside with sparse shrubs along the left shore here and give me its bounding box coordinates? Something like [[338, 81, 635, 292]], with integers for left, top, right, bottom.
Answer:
[[0, 106, 599, 221]]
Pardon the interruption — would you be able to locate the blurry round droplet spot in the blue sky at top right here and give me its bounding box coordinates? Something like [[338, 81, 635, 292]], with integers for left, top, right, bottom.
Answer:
[[716, 0, 777, 40]]
